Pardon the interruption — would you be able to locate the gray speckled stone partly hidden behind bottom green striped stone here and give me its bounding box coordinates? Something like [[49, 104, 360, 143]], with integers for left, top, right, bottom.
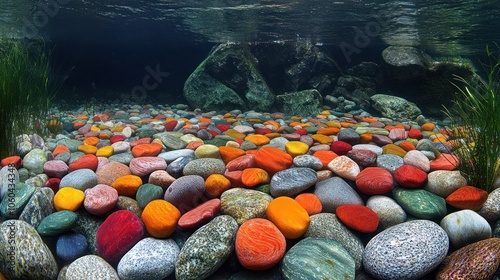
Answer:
[[304, 213, 365, 271]]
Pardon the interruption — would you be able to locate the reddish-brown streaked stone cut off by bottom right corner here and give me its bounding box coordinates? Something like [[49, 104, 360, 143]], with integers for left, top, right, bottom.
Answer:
[[436, 238, 500, 280]]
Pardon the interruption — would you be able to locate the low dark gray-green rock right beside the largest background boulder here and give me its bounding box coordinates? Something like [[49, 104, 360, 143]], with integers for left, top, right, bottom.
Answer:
[[276, 89, 323, 117]]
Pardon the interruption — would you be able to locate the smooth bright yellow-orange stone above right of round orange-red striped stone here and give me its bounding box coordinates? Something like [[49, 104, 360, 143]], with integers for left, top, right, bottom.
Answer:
[[266, 196, 311, 239]]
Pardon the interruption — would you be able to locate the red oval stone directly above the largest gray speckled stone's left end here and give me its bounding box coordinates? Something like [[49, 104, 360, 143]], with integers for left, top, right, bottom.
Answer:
[[335, 204, 379, 233]]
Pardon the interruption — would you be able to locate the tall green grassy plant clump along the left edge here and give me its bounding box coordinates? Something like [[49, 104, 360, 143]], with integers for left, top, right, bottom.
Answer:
[[0, 36, 55, 158]]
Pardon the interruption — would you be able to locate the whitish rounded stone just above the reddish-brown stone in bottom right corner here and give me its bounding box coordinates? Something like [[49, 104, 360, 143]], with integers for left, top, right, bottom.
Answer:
[[440, 210, 491, 248]]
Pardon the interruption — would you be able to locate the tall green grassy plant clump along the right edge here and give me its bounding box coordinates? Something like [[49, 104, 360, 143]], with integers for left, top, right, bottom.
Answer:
[[445, 46, 500, 192]]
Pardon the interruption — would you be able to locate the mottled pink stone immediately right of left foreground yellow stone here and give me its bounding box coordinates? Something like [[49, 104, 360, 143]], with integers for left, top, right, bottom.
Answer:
[[83, 184, 118, 216]]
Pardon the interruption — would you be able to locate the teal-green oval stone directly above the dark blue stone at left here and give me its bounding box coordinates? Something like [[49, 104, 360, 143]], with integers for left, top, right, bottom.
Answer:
[[36, 210, 78, 236]]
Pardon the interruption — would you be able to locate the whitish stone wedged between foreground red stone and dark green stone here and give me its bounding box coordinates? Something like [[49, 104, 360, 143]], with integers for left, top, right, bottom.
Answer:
[[366, 195, 407, 229]]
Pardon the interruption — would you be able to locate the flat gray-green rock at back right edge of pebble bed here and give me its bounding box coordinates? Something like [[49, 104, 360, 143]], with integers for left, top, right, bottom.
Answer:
[[370, 94, 422, 120]]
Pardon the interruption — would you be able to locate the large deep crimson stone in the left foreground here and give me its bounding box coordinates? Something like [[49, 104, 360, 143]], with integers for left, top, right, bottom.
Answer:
[[96, 210, 144, 263]]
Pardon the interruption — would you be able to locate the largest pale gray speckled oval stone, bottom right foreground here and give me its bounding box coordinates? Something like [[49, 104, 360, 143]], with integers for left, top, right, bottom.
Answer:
[[363, 220, 449, 280]]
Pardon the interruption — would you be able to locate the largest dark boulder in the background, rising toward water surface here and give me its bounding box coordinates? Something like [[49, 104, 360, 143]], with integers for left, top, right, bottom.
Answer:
[[184, 44, 274, 111]]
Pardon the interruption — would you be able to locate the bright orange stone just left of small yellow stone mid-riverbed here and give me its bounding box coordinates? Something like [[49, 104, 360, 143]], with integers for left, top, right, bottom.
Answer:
[[254, 147, 293, 176]]
